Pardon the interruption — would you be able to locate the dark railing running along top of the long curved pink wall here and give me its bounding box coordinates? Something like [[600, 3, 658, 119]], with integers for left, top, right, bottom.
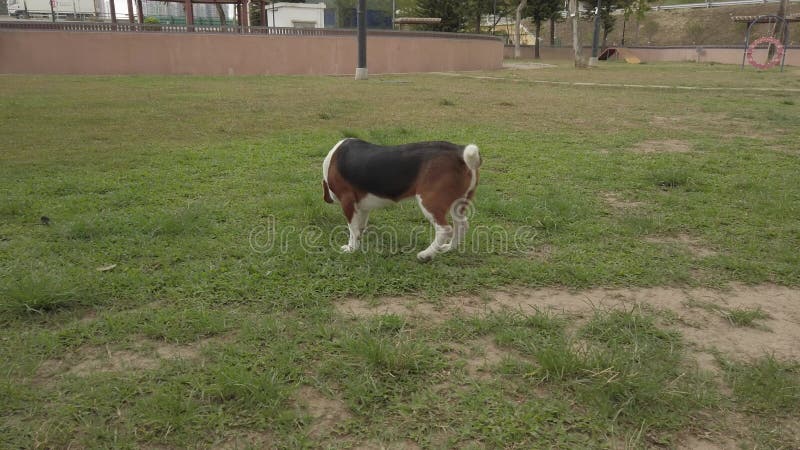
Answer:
[[0, 21, 500, 41]]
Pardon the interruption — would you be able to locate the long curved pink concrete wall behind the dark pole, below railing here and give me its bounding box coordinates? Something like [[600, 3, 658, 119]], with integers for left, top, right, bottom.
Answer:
[[0, 30, 503, 75]]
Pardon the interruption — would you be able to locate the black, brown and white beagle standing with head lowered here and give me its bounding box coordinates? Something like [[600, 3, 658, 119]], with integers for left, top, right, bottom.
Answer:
[[322, 138, 481, 261]]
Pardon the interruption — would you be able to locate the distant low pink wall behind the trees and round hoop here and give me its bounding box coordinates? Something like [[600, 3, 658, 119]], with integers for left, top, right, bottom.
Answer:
[[504, 46, 800, 66]]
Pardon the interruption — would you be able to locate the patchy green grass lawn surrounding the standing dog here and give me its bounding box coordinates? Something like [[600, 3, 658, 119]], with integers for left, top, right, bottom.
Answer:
[[0, 63, 800, 448]]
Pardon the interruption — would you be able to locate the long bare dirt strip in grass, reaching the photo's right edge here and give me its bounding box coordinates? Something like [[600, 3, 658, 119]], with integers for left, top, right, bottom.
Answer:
[[337, 284, 800, 362]]
